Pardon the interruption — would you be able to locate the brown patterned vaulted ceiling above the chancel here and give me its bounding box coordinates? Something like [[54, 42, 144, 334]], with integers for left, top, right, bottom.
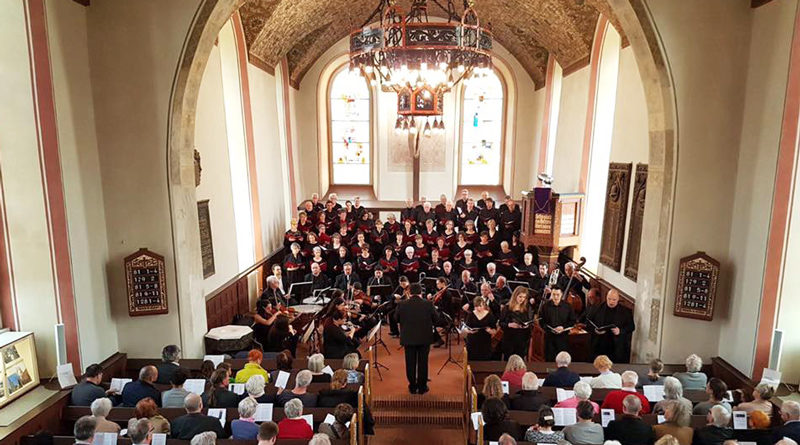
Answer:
[[239, 0, 624, 88]]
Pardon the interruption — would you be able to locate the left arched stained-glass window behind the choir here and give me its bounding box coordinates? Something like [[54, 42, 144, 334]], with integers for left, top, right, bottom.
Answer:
[[328, 68, 372, 185]]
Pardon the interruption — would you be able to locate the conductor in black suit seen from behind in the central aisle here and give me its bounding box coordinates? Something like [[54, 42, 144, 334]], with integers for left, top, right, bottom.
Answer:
[[396, 284, 436, 394]]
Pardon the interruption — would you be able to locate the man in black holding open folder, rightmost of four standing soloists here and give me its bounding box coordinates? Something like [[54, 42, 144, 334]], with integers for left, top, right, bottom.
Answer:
[[586, 289, 636, 363]]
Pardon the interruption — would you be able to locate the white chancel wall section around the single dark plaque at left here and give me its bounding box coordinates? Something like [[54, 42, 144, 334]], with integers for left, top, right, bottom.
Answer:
[[194, 45, 239, 295]]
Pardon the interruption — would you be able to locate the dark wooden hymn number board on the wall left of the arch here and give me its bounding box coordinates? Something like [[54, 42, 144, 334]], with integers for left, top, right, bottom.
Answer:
[[125, 249, 168, 316]]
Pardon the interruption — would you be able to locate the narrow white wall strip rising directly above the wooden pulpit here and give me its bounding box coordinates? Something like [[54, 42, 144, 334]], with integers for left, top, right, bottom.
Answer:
[[553, 66, 590, 193]]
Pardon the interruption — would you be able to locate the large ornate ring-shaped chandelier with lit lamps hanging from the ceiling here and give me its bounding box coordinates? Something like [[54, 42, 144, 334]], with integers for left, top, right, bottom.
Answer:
[[350, 0, 493, 119]]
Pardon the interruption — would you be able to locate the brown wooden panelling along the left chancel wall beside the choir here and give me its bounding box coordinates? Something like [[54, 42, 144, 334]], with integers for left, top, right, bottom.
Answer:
[[206, 247, 283, 330]]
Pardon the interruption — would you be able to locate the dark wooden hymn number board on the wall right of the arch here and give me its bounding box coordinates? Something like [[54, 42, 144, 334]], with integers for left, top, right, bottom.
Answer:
[[674, 252, 719, 321]]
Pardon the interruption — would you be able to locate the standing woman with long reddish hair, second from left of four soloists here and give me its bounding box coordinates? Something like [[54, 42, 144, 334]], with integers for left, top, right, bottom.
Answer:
[[500, 286, 534, 360]]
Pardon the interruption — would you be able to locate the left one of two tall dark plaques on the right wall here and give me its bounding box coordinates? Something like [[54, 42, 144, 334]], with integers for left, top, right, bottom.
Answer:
[[600, 162, 633, 272]]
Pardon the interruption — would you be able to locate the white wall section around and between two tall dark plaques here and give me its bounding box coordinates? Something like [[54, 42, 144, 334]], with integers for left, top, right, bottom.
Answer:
[[597, 46, 650, 296]]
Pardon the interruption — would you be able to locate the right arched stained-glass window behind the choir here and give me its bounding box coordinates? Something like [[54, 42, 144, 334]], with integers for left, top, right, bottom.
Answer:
[[460, 70, 506, 185]]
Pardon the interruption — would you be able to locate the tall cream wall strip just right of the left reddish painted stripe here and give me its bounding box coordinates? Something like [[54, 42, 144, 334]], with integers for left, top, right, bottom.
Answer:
[[45, 0, 119, 368]]
